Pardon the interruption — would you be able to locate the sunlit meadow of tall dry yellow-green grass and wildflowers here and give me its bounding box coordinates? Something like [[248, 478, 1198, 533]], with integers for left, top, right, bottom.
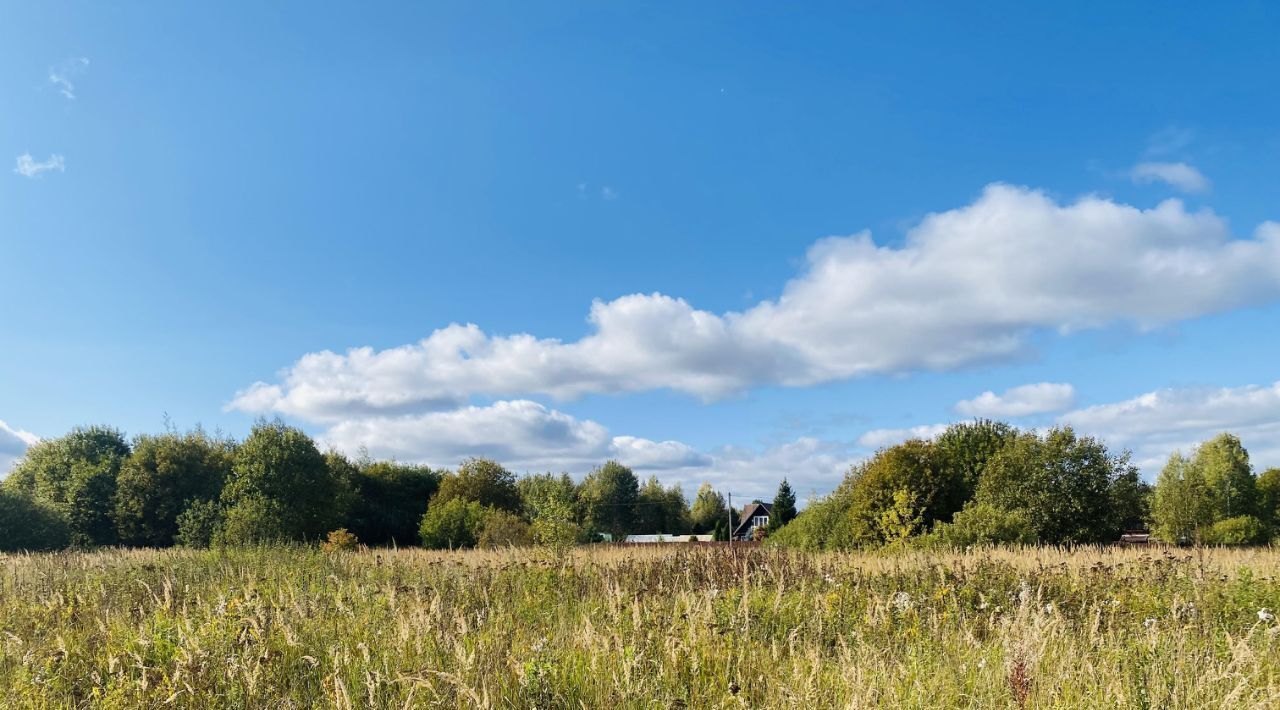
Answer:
[[0, 545, 1280, 709]]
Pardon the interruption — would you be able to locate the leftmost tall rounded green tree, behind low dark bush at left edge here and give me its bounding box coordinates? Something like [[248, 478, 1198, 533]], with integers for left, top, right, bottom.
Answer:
[[5, 426, 129, 545]]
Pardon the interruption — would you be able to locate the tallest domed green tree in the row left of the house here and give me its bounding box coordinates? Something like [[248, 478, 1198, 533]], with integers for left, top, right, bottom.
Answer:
[[221, 421, 349, 544]]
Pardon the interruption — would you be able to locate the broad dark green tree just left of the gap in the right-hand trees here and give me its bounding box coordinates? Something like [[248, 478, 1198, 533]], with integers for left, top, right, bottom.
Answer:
[[977, 427, 1132, 544]]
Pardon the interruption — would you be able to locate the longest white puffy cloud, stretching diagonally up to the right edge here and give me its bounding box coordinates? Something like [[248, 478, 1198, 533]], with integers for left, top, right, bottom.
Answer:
[[229, 184, 1280, 422]]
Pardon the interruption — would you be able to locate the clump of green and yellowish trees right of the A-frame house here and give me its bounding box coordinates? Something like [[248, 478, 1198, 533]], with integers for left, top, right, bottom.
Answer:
[[771, 420, 1280, 549]]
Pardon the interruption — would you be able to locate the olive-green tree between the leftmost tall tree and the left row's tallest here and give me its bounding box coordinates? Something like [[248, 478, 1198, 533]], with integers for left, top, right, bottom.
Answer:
[[115, 430, 234, 548]]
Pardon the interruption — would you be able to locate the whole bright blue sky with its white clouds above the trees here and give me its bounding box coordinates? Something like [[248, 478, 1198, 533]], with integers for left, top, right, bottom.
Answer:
[[0, 3, 1280, 495]]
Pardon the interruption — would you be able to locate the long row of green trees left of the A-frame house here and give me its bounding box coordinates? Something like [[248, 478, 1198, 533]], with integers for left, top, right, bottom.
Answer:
[[0, 421, 795, 550]]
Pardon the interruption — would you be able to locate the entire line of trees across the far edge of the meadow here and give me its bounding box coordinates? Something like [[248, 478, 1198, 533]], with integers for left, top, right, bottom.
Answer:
[[0, 420, 1280, 550]]
